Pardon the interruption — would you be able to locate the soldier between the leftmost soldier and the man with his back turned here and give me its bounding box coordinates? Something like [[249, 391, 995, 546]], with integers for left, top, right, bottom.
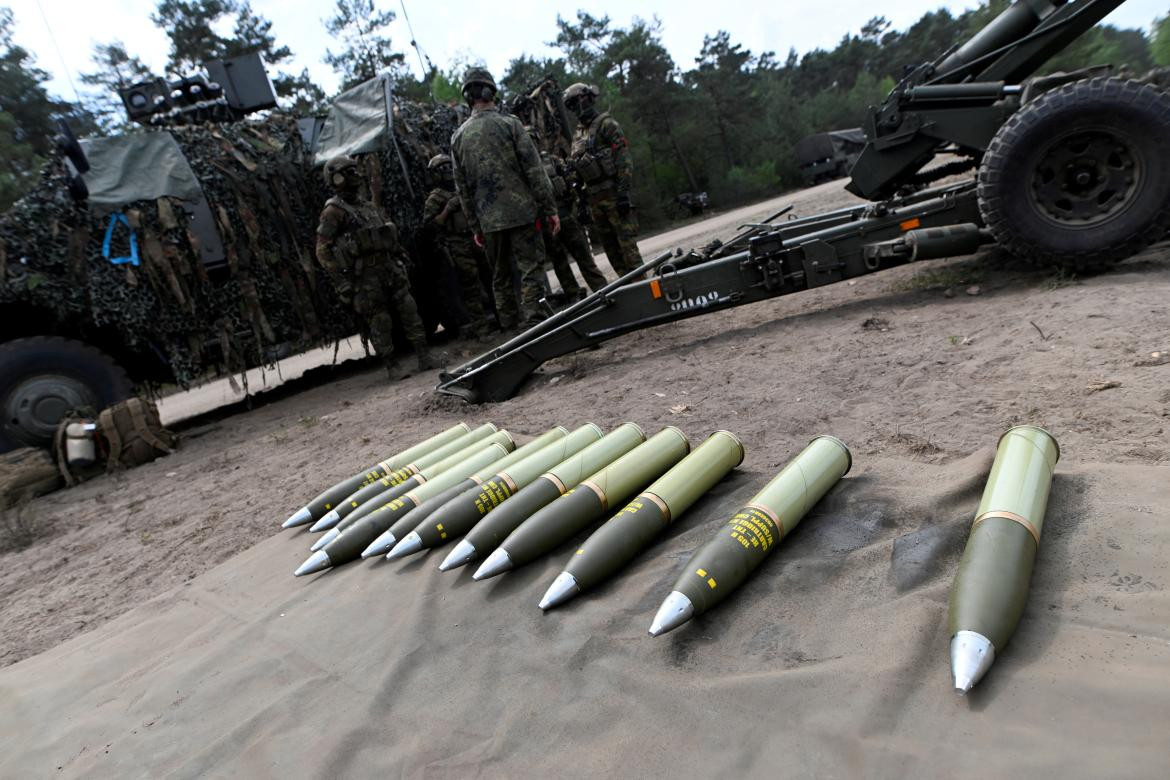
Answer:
[[422, 154, 488, 340]]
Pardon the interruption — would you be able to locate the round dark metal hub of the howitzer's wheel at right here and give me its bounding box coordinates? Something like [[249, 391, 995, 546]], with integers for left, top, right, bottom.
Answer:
[[1030, 130, 1142, 227]]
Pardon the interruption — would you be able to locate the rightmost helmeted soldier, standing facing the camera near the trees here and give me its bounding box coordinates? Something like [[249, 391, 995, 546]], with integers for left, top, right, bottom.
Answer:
[[564, 83, 642, 276]]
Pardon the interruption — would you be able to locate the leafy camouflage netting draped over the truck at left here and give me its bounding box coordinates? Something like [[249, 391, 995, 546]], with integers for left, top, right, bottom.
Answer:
[[0, 92, 475, 386]]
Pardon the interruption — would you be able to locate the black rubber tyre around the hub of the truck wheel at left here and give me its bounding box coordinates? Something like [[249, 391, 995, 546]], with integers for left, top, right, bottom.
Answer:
[[0, 336, 135, 453]]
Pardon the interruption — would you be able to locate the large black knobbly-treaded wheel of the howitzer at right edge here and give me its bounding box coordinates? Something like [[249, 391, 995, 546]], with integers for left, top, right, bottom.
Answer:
[[978, 78, 1170, 270]]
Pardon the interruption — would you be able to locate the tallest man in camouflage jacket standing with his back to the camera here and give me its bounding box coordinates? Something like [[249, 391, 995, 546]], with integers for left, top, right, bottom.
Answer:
[[450, 68, 560, 331]]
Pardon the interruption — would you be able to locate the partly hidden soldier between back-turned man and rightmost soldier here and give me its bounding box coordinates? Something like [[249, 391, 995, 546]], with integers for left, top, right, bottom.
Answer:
[[528, 127, 606, 302]]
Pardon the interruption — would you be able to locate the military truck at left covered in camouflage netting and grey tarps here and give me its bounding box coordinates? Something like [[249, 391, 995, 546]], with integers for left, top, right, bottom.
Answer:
[[0, 56, 466, 451]]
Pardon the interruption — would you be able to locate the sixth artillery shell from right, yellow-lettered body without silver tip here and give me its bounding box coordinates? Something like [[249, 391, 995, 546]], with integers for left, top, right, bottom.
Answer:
[[409, 422, 603, 547]]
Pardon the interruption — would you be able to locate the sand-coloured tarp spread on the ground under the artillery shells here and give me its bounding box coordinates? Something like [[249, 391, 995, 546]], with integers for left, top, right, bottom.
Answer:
[[0, 451, 1170, 778]]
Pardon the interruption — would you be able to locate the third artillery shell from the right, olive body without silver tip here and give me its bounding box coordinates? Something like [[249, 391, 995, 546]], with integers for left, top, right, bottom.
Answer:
[[563, 430, 743, 591]]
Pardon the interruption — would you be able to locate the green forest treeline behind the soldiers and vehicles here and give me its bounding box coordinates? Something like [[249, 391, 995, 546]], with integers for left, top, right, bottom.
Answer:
[[0, 0, 1170, 227]]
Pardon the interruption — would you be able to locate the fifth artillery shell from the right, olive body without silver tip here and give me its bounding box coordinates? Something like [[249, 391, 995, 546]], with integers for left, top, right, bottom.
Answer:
[[467, 422, 650, 558]]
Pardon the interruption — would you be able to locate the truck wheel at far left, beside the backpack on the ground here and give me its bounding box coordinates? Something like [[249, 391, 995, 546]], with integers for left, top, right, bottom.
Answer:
[[0, 336, 133, 453]]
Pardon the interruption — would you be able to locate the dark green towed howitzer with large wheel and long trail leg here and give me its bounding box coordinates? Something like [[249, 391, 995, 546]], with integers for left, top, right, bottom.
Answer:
[[436, 0, 1170, 402]]
